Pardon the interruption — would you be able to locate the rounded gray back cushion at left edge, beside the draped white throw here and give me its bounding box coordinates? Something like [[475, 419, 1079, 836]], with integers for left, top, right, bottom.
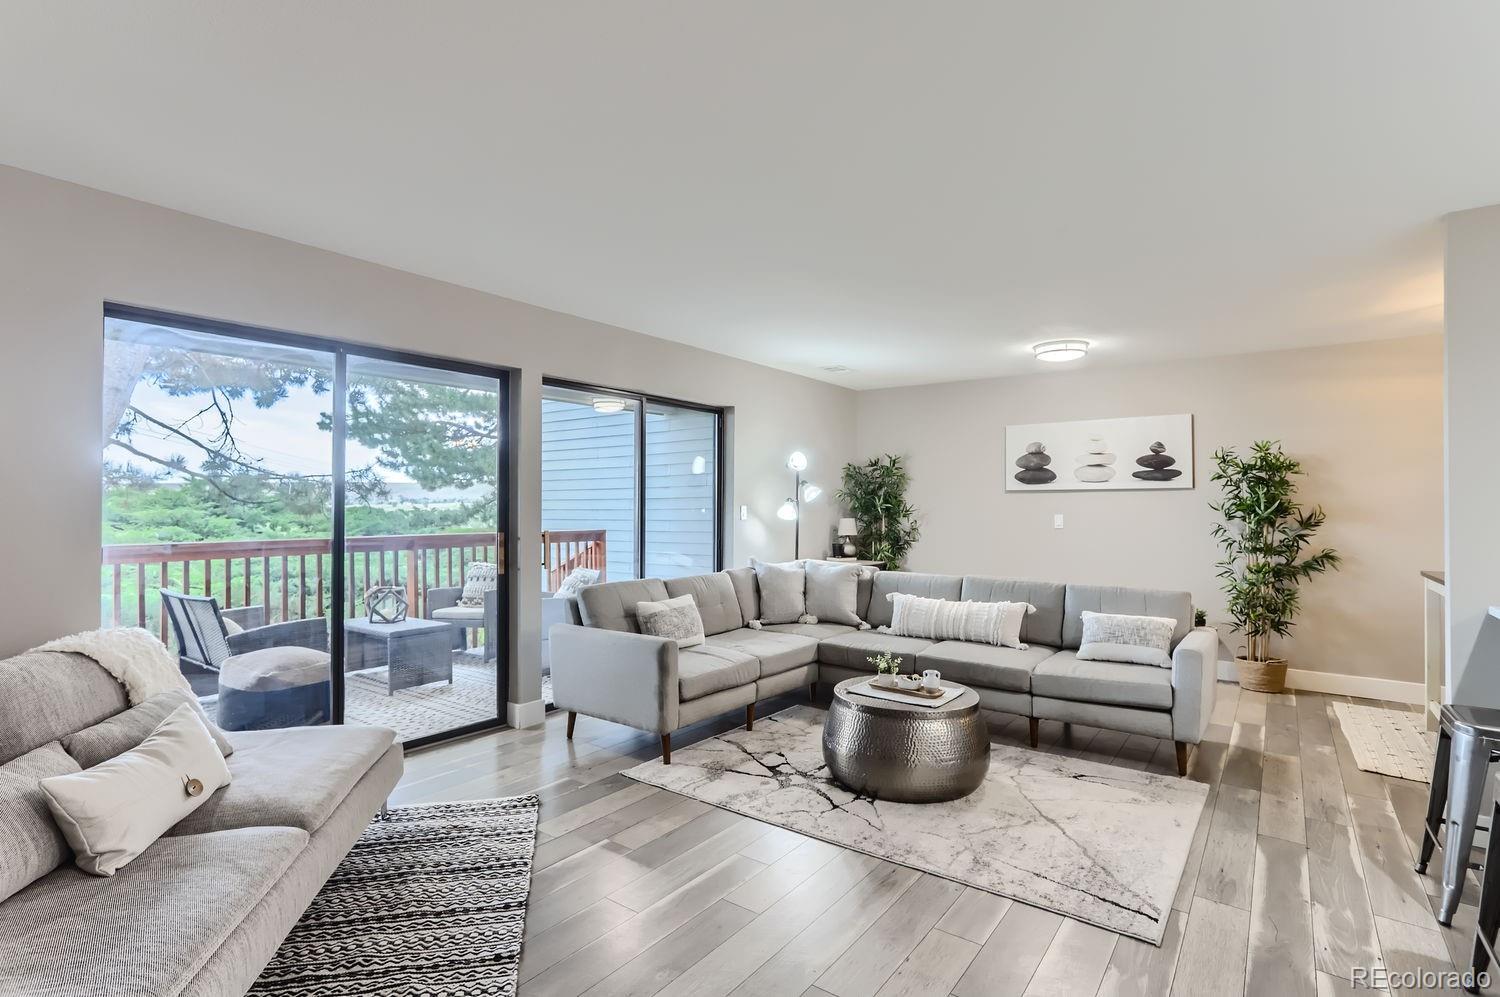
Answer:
[[0, 651, 131, 765]]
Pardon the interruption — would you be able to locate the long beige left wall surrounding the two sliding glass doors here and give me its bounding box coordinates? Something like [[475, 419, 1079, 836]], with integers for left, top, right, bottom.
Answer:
[[0, 168, 855, 702]]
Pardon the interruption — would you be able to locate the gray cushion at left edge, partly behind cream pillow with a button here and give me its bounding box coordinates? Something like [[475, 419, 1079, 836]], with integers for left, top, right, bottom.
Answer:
[[0, 741, 81, 901]]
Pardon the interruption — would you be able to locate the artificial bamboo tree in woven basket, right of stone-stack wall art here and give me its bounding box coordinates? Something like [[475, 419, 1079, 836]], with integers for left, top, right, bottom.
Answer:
[[1211, 439, 1340, 693]]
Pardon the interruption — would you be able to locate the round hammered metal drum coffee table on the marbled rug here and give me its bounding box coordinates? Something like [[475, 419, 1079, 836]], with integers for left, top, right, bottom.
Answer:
[[824, 676, 990, 804]]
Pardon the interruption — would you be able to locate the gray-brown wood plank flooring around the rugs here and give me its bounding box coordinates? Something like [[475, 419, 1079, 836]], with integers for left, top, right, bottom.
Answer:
[[392, 684, 1478, 997]]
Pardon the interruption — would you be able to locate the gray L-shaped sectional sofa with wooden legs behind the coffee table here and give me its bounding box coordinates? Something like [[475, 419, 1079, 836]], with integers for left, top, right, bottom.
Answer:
[[551, 568, 1218, 774]]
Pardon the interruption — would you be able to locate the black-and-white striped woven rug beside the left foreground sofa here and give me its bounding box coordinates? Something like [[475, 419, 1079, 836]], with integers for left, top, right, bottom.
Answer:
[[249, 796, 540, 997]]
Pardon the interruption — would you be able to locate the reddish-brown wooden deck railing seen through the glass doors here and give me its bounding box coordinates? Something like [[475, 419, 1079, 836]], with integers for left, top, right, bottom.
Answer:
[[101, 529, 605, 640]]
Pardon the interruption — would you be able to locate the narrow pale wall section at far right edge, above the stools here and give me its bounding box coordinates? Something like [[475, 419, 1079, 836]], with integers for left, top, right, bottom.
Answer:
[[1443, 205, 1500, 708]]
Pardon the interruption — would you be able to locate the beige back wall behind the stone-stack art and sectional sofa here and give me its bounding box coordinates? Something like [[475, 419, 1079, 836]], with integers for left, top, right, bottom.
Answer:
[[857, 336, 1440, 682]]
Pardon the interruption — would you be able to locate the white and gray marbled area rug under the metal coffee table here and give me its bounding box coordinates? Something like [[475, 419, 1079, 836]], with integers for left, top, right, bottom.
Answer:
[[626, 706, 1208, 945]]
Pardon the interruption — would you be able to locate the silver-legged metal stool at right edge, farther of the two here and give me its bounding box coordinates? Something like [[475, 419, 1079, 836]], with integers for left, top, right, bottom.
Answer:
[[1416, 703, 1500, 927]]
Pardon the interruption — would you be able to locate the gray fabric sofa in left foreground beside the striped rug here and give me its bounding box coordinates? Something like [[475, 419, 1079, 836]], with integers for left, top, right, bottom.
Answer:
[[0, 652, 402, 997]]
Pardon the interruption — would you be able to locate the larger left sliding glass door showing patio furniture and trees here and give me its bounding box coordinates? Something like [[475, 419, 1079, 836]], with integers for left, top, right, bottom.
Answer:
[[101, 307, 509, 745]]
